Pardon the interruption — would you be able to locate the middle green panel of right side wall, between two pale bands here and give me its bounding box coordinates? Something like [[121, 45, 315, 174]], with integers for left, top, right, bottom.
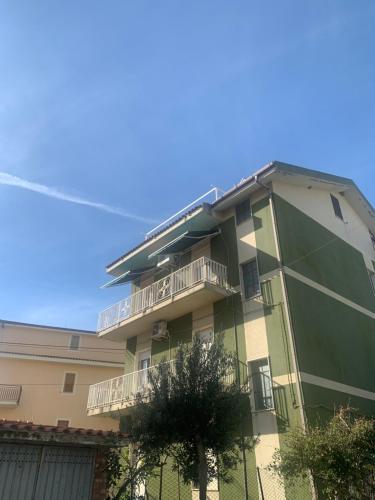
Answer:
[[286, 276, 375, 392]]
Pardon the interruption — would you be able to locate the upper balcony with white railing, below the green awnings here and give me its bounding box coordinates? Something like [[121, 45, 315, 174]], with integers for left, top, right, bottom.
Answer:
[[97, 257, 231, 341]]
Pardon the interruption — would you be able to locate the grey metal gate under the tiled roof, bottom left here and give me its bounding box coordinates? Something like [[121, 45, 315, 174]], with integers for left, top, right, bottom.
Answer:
[[0, 444, 96, 500]]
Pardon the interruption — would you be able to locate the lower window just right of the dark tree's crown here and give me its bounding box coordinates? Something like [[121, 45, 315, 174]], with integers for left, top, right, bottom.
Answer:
[[249, 358, 274, 411]]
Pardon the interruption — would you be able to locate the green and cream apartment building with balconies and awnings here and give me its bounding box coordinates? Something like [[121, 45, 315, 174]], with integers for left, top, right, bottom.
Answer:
[[88, 161, 375, 500]]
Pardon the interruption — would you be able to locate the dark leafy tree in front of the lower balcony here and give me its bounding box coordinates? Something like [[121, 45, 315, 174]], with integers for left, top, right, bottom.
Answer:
[[130, 338, 253, 500]]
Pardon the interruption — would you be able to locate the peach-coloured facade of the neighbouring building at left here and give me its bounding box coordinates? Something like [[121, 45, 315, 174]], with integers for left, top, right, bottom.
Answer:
[[0, 323, 124, 430]]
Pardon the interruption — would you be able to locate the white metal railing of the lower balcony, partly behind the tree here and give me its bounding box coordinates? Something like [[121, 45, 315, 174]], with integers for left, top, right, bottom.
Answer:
[[87, 360, 235, 410]]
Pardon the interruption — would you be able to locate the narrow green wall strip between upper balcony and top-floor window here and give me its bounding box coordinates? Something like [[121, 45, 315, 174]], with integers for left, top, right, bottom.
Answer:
[[211, 217, 240, 286]]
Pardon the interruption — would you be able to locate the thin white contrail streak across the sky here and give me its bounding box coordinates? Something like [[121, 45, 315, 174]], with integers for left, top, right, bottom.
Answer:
[[0, 172, 158, 224]]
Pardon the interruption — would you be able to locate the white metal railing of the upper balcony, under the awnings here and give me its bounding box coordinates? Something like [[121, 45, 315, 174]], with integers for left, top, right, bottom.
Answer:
[[97, 257, 228, 332]]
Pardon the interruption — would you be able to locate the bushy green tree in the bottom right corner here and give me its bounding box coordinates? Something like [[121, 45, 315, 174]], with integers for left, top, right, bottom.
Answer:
[[271, 407, 375, 500]]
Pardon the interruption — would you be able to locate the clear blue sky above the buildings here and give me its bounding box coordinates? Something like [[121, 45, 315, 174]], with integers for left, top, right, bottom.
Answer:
[[0, 0, 375, 329]]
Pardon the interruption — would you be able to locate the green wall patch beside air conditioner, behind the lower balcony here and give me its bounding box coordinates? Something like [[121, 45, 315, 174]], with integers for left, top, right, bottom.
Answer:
[[151, 313, 193, 365]]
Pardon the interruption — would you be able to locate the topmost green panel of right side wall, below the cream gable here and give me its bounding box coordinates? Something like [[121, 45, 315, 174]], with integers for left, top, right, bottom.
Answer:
[[274, 194, 375, 311]]
